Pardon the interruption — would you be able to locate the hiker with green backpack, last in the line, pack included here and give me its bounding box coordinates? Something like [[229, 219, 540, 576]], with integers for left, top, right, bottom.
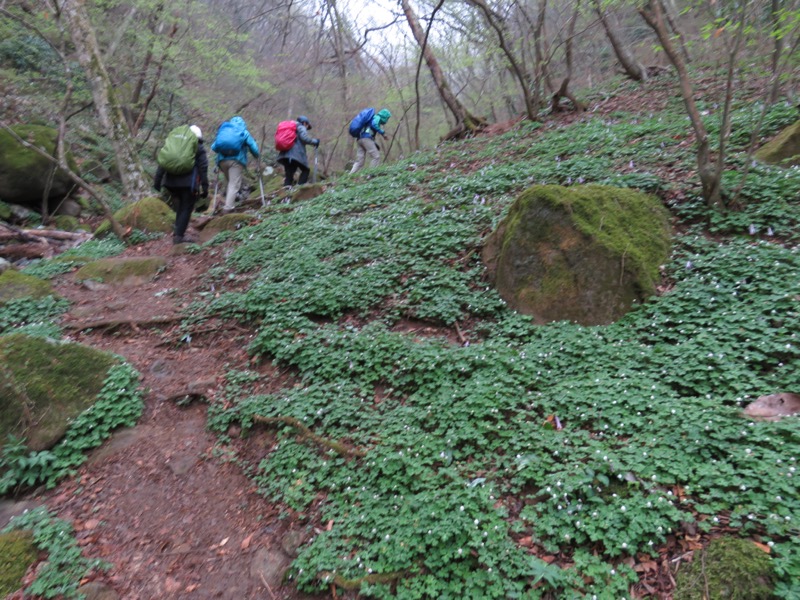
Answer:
[[153, 125, 208, 244]]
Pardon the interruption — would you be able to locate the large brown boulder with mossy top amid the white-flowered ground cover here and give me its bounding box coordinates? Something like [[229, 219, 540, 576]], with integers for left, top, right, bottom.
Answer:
[[483, 185, 671, 325]]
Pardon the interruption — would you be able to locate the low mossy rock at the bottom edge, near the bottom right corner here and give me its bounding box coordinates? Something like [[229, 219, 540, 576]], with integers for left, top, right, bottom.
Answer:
[[673, 537, 775, 600]]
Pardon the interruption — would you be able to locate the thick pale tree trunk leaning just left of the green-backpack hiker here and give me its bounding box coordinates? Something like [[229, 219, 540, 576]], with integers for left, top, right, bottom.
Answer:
[[58, 0, 150, 202]]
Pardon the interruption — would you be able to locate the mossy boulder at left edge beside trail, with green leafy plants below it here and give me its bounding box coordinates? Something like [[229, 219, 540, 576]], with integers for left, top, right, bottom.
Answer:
[[0, 334, 119, 450]]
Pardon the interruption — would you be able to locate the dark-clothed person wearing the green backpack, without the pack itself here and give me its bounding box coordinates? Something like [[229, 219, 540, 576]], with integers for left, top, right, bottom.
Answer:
[[153, 125, 208, 244]]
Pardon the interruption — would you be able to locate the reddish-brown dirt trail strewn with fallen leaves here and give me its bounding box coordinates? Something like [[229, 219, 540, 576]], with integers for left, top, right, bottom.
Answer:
[[7, 238, 318, 600]]
